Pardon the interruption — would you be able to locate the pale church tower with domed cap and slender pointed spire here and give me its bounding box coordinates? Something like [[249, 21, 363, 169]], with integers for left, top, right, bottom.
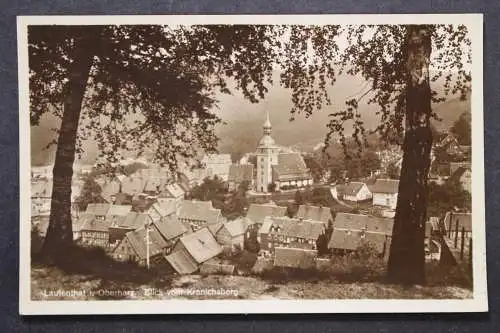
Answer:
[[255, 111, 279, 193]]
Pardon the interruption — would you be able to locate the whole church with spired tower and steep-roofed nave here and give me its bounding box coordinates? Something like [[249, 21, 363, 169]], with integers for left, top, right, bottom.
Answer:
[[255, 112, 313, 193]]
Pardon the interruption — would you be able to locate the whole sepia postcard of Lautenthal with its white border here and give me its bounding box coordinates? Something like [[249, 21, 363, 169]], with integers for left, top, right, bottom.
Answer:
[[18, 14, 488, 315]]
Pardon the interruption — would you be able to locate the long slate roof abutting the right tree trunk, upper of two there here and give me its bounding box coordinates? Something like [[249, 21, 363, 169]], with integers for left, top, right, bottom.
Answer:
[[333, 212, 394, 235]]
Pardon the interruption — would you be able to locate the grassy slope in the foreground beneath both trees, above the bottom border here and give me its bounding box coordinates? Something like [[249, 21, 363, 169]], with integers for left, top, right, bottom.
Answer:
[[31, 265, 472, 300]]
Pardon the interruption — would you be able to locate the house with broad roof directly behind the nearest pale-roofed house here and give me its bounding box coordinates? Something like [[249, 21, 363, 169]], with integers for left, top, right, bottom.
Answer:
[[179, 200, 221, 231]]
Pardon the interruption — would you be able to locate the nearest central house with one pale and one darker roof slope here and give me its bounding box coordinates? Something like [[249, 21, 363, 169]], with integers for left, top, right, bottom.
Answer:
[[165, 228, 222, 274]]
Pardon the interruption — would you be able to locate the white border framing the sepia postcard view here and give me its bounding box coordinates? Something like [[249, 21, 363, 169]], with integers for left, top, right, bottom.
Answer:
[[17, 14, 488, 315]]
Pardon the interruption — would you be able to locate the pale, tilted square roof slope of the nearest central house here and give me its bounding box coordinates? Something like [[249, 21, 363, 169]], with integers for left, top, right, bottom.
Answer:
[[179, 228, 222, 264]]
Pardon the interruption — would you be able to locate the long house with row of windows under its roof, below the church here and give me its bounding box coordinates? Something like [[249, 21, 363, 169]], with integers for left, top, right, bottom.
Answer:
[[259, 217, 326, 253]]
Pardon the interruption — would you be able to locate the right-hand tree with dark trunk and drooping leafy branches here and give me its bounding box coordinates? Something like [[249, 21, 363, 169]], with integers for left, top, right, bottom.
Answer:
[[276, 25, 471, 284]]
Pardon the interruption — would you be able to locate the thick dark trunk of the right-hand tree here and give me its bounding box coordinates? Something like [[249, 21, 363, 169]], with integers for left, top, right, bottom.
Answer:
[[387, 26, 432, 285]]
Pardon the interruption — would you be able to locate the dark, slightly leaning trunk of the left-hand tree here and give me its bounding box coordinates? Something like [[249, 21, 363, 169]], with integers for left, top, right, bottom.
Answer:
[[42, 31, 99, 260]]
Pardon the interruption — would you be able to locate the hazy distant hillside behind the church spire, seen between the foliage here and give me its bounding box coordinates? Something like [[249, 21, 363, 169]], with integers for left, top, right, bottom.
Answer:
[[31, 76, 471, 165]]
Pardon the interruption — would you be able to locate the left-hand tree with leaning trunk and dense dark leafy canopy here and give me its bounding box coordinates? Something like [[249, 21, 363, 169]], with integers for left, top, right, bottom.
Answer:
[[28, 25, 274, 258]]
